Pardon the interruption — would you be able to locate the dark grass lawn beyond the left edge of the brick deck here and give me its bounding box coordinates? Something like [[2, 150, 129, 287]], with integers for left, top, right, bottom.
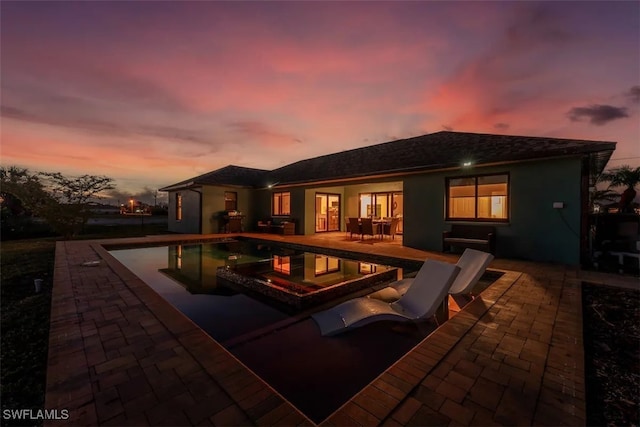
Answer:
[[0, 224, 167, 425]]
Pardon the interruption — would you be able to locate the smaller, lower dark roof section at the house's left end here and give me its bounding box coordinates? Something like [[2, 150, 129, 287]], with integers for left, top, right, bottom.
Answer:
[[160, 165, 269, 191]]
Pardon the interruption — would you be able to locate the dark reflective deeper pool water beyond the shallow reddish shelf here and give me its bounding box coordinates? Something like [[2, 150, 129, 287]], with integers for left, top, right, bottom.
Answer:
[[110, 240, 408, 343]]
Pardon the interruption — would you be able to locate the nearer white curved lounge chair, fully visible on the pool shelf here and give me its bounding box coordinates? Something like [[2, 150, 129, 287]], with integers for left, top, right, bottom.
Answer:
[[311, 260, 460, 336]]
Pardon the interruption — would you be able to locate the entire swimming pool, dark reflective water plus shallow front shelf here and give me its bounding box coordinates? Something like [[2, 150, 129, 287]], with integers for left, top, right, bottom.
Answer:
[[110, 239, 497, 423]]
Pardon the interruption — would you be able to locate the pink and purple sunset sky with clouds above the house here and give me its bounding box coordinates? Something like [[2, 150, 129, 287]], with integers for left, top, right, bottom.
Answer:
[[0, 1, 640, 201]]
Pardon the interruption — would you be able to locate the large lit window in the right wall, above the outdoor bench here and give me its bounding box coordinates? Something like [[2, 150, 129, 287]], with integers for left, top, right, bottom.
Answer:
[[447, 174, 509, 221]]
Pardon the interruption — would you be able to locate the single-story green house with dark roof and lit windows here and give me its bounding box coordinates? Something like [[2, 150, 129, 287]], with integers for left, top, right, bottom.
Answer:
[[161, 131, 616, 265]]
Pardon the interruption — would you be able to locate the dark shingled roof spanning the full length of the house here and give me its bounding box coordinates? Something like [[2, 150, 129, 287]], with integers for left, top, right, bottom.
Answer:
[[160, 131, 616, 191]]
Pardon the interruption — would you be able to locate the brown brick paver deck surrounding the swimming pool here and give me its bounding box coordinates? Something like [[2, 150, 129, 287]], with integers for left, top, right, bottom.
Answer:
[[45, 235, 637, 425]]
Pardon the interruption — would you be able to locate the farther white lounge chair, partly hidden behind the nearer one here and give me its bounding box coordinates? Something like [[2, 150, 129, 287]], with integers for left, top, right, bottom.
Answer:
[[369, 248, 494, 302]]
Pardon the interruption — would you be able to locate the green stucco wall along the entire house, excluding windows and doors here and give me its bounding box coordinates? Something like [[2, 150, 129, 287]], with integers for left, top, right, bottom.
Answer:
[[164, 158, 581, 265]]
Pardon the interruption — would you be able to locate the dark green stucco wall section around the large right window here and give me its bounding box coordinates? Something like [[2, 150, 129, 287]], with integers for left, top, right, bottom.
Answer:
[[404, 158, 580, 265]]
